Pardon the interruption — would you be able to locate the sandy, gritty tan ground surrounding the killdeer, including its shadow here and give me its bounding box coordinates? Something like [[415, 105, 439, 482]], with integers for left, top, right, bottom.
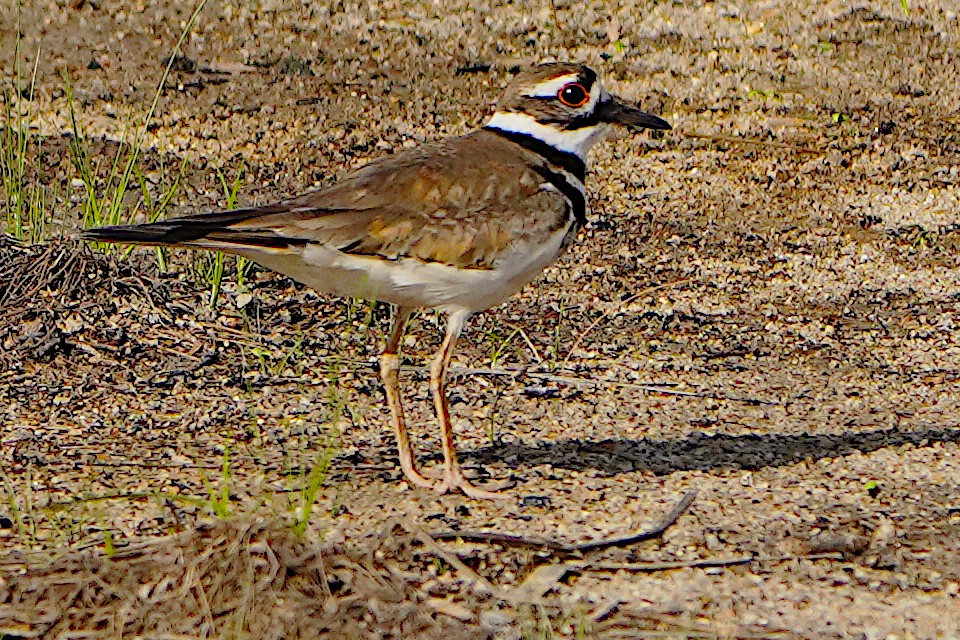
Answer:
[[0, 0, 960, 638]]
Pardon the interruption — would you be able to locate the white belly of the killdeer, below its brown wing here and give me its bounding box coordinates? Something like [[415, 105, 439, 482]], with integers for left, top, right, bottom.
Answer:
[[238, 223, 572, 312]]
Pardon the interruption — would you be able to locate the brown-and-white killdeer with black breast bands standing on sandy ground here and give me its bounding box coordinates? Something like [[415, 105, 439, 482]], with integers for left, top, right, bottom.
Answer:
[[83, 63, 670, 498]]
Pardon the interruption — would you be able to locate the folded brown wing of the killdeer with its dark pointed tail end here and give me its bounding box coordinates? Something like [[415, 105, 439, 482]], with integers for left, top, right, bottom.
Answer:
[[87, 131, 570, 269]]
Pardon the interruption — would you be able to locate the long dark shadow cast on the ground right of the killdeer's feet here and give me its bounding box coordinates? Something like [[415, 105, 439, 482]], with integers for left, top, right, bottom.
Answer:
[[462, 425, 960, 476]]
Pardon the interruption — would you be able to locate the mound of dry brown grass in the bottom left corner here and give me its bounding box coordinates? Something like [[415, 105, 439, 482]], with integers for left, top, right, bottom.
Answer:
[[0, 518, 486, 640]]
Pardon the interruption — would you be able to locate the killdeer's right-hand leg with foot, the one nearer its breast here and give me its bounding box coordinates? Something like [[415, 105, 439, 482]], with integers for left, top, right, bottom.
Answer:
[[430, 311, 509, 499]]
